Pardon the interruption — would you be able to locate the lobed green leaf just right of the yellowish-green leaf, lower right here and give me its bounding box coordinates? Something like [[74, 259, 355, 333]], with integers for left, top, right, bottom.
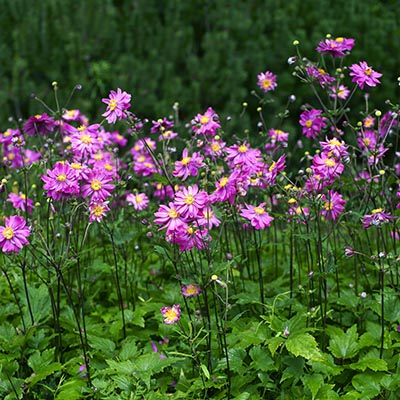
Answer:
[[328, 325, 358, 359]]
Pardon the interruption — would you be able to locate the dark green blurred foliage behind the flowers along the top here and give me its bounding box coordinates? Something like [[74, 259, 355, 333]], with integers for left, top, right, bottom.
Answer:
[[0, 0, 400, 134]]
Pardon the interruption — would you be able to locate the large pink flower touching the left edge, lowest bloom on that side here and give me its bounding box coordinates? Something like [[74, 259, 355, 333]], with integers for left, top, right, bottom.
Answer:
[[0, 215, 30, 253]]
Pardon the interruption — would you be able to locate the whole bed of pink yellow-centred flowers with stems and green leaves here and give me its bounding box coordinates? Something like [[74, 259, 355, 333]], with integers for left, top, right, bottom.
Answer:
[[0, 36, 400, 400]]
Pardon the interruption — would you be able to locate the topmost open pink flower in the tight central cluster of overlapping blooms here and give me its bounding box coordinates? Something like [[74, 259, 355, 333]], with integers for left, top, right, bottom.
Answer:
[[174, 185, 208, 219]]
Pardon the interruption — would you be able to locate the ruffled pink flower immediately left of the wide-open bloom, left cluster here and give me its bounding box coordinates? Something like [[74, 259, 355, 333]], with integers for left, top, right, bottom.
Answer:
[[42, 162, 79, 201]]
